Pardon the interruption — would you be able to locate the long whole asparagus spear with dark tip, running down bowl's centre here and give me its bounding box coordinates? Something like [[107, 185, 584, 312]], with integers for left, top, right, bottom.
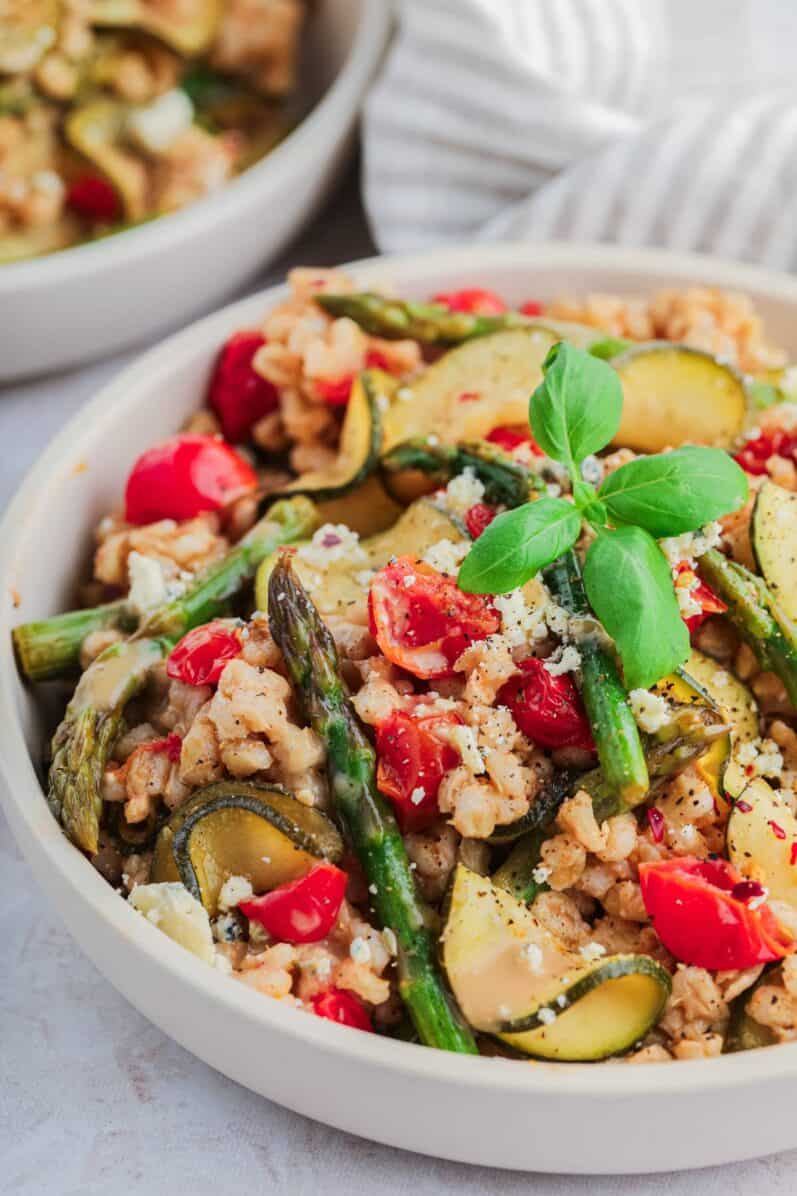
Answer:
[[268, 556, 476, 1054]]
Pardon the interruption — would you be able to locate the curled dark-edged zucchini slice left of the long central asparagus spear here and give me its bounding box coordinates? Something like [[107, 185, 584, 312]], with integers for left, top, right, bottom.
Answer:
[[152, 781, 343, 916]]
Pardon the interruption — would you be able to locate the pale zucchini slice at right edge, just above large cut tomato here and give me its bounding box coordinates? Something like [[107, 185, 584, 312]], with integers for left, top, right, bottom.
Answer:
[[726, 777, 797, 908]]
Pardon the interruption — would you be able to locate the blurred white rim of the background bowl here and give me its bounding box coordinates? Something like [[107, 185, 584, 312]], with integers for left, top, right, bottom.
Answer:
[[0, 0, 391, 287]]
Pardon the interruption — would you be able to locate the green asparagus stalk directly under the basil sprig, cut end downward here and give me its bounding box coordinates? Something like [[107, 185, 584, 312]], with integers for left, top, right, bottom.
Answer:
[[543, 549, 649, 810]]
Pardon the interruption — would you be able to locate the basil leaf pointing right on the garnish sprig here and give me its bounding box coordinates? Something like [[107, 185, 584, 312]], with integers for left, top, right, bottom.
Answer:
[[598, 445, 748, 536]]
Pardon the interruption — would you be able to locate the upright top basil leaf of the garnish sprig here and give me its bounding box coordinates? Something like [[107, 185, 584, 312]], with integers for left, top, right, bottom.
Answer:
[[529, 341, 622, 470]]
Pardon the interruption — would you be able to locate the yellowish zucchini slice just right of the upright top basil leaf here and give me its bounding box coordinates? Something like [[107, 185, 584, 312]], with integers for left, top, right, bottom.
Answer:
[[612, 341, 747, 453]]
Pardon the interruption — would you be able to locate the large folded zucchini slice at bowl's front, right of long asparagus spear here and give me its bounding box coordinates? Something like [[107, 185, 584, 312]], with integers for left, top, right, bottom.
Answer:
[[443, 864, 670, 1062]]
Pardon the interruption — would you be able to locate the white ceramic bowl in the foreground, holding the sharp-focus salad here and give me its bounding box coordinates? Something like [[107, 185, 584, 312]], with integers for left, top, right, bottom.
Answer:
[[0, 245, 797, 1173]]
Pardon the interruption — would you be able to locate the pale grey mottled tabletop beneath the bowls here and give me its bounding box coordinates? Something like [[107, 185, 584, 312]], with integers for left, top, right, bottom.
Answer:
[[0, 171, 797, 1196]]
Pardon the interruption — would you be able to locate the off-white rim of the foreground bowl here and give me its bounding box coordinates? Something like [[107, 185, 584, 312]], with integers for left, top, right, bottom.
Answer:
[[0, 242, 797, 1097]]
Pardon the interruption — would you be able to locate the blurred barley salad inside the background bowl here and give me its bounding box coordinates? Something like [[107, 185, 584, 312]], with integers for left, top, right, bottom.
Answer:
[[0, 0, 305, 264]]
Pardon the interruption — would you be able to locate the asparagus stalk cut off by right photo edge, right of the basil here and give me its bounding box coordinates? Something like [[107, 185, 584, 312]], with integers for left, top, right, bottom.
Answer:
[[698, 548, 797, 706]]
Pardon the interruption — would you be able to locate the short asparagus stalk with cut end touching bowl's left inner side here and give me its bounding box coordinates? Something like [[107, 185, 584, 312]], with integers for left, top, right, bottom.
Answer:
[[11, 599, 139, 681]]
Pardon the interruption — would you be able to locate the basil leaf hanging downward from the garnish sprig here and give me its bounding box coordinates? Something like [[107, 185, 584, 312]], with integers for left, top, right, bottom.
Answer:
[[584, 527, 689, 689]]
